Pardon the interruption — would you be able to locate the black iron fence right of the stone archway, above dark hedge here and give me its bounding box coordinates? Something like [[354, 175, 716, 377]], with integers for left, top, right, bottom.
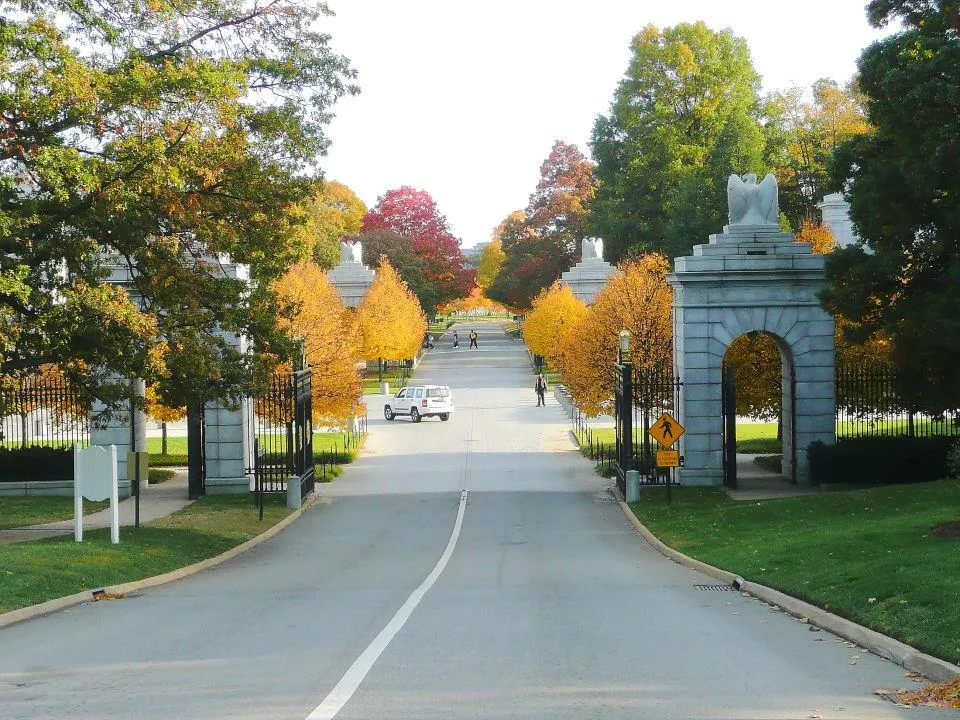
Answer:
[[836, 363, 960, 439]]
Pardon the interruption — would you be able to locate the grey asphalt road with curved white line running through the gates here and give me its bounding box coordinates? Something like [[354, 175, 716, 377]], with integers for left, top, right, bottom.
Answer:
[[0, 323, 949, 720]]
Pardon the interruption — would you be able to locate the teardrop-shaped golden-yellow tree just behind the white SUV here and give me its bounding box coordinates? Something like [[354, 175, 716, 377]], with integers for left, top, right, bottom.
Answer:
[[355, 257, 427, 380]]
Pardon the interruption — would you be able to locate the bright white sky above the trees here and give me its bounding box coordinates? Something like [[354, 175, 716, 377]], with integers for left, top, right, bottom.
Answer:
[[320, 0, 881, 247]]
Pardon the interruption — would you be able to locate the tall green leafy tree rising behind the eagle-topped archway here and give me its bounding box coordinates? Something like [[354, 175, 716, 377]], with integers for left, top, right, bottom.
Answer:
[[590, 22, 764, 262]]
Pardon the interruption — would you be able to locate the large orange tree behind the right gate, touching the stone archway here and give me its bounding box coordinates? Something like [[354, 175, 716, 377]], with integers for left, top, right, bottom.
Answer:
[[561, 253, 673, 417]]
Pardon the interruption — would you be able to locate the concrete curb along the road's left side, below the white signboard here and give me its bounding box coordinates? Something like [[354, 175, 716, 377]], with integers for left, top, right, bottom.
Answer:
[[0, 491, 320, 629]]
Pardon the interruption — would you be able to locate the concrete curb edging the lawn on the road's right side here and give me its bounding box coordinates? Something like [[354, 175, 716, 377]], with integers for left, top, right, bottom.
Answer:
[[617, 497, 960, 682]]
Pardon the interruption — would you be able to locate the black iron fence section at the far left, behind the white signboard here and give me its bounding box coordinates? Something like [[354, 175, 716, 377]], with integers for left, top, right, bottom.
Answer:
[[0, 376, 90, 449]]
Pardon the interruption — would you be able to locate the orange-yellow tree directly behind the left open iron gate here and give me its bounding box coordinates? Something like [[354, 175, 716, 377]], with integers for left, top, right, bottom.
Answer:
[[276, 260, 362, 425]]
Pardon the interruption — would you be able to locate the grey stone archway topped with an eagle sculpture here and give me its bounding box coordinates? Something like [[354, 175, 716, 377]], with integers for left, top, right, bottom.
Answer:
[[667, 175, 836, 485]]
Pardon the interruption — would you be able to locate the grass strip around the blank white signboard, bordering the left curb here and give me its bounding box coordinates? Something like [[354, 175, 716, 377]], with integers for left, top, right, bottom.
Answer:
[[0, 494, 291, 612]]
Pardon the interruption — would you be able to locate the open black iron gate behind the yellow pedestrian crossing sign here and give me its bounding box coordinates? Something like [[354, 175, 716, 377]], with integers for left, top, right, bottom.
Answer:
[[614, 361, 683, 495]]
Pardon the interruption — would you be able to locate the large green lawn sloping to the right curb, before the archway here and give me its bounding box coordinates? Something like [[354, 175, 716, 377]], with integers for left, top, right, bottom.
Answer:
[[631, 480, 960, 663]]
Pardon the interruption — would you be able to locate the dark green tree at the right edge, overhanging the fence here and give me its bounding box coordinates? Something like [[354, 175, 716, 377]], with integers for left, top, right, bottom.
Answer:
[[822, 0, 960, 412]]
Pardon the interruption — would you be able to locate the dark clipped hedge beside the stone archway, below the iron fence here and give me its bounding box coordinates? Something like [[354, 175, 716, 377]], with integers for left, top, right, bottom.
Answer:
[[807, 437, 957, 485]]
